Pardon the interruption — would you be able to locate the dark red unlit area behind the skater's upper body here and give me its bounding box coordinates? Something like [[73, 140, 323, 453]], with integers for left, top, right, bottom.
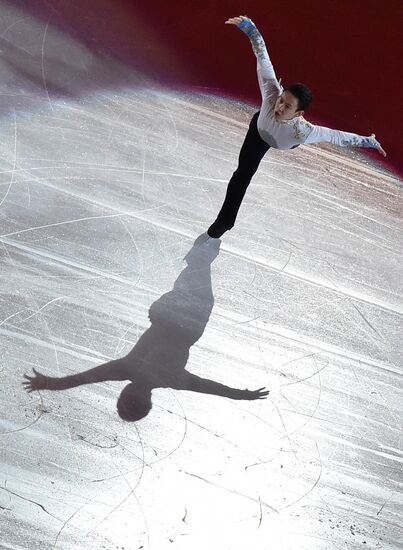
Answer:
[[12, 0, 403, 175]]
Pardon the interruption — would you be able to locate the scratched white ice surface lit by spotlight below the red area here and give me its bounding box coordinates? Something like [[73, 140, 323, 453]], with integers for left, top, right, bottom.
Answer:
[[0, 3, 403, 550]]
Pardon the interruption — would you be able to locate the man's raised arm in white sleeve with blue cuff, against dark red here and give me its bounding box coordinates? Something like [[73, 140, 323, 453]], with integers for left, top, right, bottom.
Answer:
[[225, 15, 283, 99]]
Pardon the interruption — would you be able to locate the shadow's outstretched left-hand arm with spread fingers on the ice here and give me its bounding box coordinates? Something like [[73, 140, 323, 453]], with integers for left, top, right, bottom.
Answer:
[[23, 361, 129, 392]]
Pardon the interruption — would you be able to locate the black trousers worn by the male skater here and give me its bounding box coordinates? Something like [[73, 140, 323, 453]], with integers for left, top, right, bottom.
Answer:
[[214, 112, 270, 229]]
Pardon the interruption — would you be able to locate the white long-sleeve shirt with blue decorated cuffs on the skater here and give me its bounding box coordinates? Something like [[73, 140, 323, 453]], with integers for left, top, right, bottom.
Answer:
[[243, 20, 377, 149]]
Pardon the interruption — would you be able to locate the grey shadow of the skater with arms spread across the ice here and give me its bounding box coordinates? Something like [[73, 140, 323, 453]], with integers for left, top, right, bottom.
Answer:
[[24, 234, 269, 421]]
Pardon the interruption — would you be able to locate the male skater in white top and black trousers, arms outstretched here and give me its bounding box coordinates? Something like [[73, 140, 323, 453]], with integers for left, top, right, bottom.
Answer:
[[207, 16, 386, 238]]
